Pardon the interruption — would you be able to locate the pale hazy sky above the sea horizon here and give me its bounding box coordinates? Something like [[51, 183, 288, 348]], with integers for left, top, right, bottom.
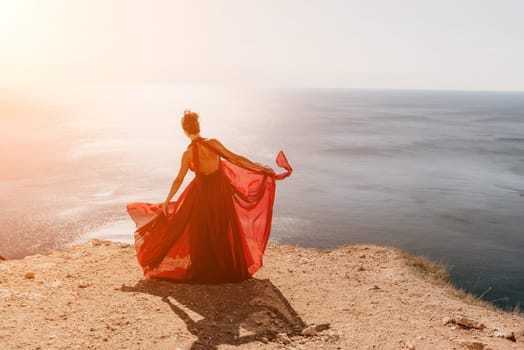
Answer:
[[0, 0, 524, 90]]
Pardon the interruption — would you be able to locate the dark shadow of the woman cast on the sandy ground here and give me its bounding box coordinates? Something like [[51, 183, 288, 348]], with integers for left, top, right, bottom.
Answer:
[[121, 278, 329, 349]]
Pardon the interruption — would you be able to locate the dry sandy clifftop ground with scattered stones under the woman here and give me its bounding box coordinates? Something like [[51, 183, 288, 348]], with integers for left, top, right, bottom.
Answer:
[[0, 240, 524, 350]]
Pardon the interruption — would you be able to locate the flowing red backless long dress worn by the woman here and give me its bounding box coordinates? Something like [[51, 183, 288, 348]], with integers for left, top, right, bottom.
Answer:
[[127, 138, 292, 283]]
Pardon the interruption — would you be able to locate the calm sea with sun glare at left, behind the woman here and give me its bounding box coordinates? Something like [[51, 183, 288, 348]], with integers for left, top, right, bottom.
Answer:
[[0, 84, 524, 310]]
